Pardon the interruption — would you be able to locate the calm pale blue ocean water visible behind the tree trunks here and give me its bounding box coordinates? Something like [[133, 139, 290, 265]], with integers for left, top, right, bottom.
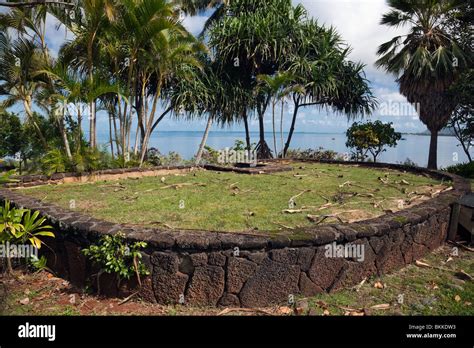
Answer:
[[98, 131, 474, 168]]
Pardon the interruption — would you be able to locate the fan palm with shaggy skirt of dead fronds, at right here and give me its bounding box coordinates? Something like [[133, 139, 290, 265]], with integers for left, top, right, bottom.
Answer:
[[376, 0, 472, 169]]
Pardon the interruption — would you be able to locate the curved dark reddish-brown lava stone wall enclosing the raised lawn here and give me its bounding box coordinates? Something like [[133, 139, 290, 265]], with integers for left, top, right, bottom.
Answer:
[[0, 162, 470, 307]]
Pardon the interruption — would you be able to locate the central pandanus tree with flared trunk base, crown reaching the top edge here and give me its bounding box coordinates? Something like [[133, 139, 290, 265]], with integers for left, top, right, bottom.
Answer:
[[209, 0, 306, 158]]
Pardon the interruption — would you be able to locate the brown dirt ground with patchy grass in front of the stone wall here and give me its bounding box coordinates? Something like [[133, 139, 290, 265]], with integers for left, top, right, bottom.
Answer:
[[0, 245, 474, 316]]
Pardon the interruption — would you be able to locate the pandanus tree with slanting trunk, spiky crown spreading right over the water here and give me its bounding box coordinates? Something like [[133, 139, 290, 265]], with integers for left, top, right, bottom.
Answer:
[[283, 20, 376, 156]]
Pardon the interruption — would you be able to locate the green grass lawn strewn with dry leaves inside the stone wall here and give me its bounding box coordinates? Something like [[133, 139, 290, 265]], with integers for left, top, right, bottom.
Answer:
[[21, 163, 450, 231]]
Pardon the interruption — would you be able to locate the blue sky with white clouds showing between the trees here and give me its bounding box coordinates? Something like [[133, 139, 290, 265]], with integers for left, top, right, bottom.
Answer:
[[4, 0, 426, 133]]
